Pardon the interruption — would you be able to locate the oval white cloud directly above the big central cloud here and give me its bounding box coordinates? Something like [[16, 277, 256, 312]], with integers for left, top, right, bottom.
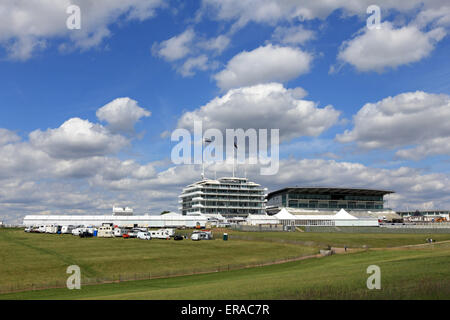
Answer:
[[214, 44, 313, 90]]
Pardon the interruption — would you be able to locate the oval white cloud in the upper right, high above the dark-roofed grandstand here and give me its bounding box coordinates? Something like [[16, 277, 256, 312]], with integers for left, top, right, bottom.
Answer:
[[338, 22, 446, 72]]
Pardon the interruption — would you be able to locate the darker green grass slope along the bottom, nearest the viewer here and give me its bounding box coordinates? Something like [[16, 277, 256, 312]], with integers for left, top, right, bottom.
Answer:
[[0, 247, 450, 300]]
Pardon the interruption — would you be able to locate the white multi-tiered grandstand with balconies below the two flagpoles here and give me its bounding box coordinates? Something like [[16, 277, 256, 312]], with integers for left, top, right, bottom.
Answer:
[[179, 177, 267, 219]]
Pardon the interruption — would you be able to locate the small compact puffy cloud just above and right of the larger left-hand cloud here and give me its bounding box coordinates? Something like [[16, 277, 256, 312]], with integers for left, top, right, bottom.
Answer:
[[97, 97, 151, 133]]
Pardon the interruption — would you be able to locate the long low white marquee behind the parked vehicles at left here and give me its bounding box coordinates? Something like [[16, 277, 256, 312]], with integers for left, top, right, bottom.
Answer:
[[23, 212, 208, 228]]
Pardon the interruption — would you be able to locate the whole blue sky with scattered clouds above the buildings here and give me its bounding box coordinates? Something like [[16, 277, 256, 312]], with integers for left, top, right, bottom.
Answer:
[[0, 0, 450, 221]]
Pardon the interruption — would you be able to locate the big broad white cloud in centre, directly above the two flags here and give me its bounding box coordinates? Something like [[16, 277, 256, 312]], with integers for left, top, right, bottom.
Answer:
[[178, 83, 340, 140]]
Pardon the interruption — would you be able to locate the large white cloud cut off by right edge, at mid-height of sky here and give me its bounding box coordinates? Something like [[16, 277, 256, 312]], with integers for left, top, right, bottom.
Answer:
[[336, 91, 450, 159]]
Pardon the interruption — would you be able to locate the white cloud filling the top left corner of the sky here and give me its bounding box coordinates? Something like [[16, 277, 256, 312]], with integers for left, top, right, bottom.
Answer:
[[0, 0, 165, 60]]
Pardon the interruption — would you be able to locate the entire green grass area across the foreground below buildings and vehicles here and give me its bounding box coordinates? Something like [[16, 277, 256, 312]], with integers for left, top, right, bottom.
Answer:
[[0, 229, 450, 299]]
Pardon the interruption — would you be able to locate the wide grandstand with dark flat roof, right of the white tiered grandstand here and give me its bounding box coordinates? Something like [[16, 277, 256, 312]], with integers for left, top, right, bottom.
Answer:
[[266, 187, 402, 221]]
